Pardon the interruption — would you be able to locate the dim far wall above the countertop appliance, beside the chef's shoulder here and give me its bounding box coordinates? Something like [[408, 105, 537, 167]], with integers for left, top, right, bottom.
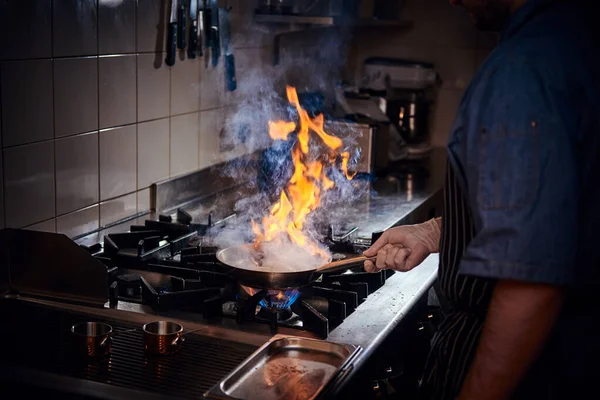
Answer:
[[350, 0, 497, 146]]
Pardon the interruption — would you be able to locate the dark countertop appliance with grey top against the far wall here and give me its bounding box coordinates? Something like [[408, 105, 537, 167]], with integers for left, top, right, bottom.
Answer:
[[361, 57, 439, 159]]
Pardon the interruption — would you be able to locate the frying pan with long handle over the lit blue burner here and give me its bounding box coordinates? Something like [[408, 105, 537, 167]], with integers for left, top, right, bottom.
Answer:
[[217, 243, 375, 290]]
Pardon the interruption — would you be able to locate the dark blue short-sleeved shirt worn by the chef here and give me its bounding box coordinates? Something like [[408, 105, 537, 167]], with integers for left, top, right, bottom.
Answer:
[[448, 0, 600, 287]]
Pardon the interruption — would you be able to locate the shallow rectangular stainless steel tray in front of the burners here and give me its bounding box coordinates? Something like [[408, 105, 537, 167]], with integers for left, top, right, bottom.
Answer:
[[205, 335, 362, 400]]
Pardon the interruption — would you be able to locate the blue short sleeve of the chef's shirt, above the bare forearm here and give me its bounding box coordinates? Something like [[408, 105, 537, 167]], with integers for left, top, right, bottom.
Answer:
[[460, 59, 579, 285]]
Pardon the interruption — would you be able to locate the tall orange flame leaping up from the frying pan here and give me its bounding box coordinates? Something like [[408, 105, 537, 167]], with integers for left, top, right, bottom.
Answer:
[[252, 86, 354, 258]]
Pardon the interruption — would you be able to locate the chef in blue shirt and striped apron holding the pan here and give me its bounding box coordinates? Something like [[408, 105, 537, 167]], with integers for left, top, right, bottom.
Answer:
[[364, 0, 600, 400]]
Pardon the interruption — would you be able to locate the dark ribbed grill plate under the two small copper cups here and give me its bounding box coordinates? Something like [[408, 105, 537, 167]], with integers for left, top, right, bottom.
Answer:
[[0, 301, 257, 398]]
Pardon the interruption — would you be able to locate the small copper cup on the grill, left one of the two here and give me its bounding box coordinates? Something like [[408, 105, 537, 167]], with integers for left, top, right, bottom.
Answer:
[[71, 322, 112, 357]]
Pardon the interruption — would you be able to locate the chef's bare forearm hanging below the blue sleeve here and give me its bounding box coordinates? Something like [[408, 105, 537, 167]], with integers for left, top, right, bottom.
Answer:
[[458, 280, 564, 400]]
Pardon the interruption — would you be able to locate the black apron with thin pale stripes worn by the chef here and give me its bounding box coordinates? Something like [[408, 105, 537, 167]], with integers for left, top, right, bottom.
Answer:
[[421, 163, 494, 400]]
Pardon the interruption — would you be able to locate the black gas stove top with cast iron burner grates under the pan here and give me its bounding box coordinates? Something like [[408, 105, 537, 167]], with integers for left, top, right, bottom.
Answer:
[[87, 209, 394, 338]]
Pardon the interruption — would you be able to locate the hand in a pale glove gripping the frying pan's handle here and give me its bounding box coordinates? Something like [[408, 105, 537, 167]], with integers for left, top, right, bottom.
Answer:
[[363, 218, 441, 272]]
